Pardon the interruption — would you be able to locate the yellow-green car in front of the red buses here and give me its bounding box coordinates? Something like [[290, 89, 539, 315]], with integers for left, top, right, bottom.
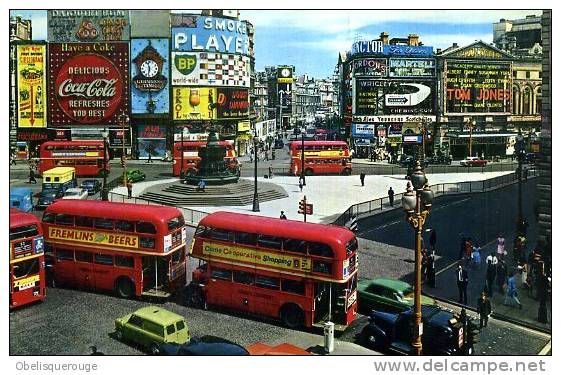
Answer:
[[115, 306, 189, 354]]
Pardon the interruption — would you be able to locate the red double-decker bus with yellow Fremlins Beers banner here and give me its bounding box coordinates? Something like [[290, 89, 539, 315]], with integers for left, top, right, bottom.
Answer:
[[43, 200, 187, 298]]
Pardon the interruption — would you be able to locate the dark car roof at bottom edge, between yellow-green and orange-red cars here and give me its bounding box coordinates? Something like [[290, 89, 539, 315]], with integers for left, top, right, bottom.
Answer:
[[160, 336, 249, 355]]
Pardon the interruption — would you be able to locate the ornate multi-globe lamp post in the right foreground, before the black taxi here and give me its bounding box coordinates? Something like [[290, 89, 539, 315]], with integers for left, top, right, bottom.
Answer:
[[401, 160, 434, 355]]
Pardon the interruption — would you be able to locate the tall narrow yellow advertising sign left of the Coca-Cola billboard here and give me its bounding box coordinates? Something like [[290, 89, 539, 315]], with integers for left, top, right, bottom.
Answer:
[[16, 44, 47, 128]]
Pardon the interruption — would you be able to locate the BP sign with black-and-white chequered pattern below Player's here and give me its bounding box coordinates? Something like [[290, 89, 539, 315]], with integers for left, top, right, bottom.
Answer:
[[171, 52, 251, 88]]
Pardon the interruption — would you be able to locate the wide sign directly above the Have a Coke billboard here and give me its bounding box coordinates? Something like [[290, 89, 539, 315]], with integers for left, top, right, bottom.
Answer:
[[47, 9, 130, 43]]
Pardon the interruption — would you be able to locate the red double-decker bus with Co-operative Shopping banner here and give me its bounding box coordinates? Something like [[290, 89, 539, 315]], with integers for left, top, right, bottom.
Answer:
[[187, 212, 358, 330]]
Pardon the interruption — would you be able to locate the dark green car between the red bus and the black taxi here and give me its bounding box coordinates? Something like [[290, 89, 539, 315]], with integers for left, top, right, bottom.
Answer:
[[357, 279, 436, 315]]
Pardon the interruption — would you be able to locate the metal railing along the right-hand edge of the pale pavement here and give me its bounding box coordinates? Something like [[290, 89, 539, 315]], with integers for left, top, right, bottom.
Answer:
[[332, 169, 538, 226]]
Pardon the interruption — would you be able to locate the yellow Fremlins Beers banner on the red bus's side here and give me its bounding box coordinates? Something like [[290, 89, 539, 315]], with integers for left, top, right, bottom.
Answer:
[[49, 227, 138, 249]]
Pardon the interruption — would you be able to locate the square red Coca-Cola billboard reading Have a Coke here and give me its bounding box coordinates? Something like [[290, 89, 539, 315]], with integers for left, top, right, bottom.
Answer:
[[49, 43, 129, 126]]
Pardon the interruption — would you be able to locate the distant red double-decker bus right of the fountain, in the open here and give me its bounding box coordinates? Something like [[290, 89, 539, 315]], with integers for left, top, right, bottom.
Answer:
[[290, 140, 352, 176]]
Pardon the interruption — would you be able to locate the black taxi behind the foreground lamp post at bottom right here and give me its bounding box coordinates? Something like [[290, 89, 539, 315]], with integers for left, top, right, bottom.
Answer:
[[359, 305, 478, 355]]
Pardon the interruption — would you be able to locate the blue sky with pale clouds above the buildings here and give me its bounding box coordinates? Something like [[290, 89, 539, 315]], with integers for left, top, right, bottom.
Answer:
[[10, 10, 541, 78]]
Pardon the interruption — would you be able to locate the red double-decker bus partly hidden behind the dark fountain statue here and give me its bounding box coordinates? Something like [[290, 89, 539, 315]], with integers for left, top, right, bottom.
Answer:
[[173, 141, 239, 176]]
